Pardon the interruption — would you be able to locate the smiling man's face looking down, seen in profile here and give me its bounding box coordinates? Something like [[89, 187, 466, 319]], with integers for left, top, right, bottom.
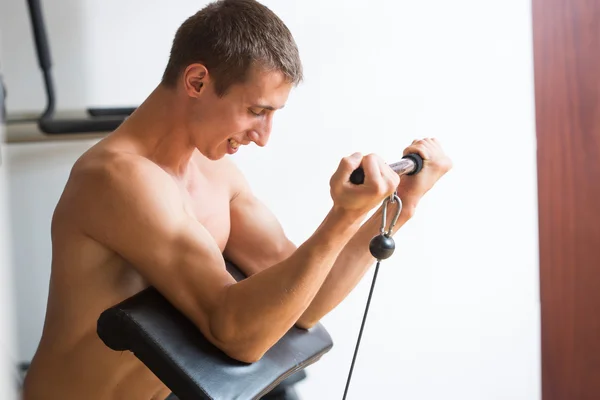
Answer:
[[190, 66, 292, 160]]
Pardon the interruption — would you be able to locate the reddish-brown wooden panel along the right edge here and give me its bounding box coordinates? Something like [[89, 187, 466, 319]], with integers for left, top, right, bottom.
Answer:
[[532, 0, 600, 400]]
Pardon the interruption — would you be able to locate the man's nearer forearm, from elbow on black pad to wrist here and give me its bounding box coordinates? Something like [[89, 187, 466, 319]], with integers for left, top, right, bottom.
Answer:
[[212, 210, 361, 359]]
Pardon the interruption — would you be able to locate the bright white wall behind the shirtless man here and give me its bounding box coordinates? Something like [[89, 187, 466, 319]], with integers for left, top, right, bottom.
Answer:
[[0, 0, 540, 400]]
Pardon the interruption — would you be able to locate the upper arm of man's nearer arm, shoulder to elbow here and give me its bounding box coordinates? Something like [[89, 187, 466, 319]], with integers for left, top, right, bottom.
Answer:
[[72, 162, 235, 336]]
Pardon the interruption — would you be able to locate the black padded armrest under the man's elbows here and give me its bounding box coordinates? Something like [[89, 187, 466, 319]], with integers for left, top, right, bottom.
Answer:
[[97, 263, 333, 400]]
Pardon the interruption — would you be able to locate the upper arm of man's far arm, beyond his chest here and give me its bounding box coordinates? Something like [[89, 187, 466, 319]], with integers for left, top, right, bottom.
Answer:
[[224, 190, 296, 275]]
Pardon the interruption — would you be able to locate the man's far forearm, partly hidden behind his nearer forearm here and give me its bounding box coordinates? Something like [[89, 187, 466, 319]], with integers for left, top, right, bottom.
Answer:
[[297, 200, 415, 328]]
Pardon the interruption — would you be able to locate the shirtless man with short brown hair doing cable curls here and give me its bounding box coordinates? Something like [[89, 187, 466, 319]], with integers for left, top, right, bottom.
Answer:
[[24, 0, 451, 400]]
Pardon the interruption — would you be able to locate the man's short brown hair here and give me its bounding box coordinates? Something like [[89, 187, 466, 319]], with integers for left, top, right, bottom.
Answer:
[[162, 0, 302, 96]]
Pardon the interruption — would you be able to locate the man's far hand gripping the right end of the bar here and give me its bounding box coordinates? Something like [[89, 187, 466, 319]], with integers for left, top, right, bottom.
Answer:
[[398, 138, 452, 208]]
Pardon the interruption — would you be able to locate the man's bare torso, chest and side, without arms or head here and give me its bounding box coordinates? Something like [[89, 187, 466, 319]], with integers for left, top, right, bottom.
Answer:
[[24, 135, 239, 400]]
